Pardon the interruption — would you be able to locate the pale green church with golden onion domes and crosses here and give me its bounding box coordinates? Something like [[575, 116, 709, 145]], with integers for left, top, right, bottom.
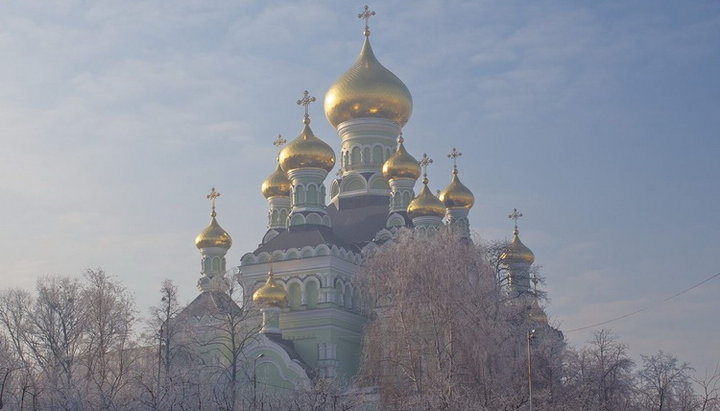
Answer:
[[186, 6, 534, 389]]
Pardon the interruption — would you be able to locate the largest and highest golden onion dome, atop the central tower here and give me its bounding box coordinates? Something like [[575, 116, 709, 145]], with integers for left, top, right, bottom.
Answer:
[[324, 36, 412, 128]]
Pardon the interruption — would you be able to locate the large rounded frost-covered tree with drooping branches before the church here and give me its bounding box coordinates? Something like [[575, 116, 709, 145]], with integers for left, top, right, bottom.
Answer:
[[358, 230, 563, 410]]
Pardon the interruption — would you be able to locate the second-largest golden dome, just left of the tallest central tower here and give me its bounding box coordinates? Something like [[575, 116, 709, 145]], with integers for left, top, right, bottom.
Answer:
[[280, 123, 335, 172]]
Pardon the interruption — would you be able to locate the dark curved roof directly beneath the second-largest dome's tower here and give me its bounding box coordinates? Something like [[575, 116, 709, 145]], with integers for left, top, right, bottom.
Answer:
[[253, 224, 358, 255]]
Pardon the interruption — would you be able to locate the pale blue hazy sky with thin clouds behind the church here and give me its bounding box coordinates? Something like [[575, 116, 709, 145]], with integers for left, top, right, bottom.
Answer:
[[0, 0, 720, 370]]
